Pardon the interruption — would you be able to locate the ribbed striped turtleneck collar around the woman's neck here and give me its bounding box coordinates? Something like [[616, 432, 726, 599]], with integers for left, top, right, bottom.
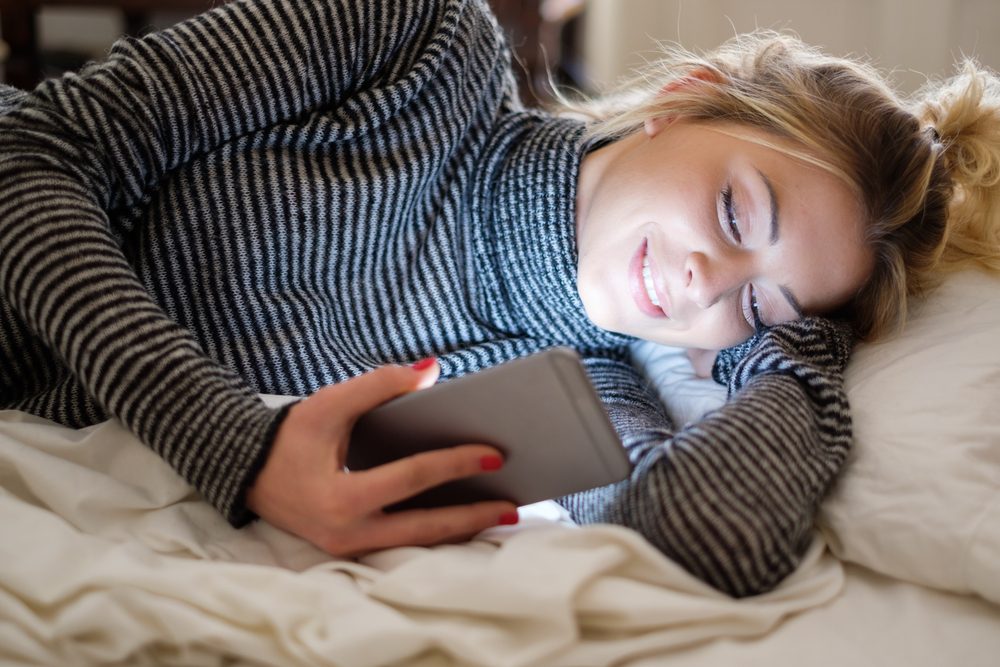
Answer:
[[470, 111, 631, 351]]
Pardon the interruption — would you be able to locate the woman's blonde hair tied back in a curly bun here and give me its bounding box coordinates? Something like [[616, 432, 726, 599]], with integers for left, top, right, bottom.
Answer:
[[562, 31, 1000, 340]]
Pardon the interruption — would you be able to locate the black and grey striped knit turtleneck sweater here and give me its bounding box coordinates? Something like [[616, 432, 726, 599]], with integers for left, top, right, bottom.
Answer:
[[0, 0, 850, 595]]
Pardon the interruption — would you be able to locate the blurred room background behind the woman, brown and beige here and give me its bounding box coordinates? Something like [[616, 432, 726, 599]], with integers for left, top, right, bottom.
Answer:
[[0, 0, 1000, 104]]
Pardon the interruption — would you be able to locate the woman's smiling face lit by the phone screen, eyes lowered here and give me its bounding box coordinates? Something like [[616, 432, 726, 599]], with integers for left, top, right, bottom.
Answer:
[[577, 121, 872, 349]]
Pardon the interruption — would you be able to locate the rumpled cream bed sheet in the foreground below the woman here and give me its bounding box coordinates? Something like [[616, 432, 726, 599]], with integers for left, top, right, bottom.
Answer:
[[0, 402, 1000, 667]]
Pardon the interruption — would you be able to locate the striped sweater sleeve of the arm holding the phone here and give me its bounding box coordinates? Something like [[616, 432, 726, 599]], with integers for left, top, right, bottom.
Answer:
[[0, 0, 456, 525]]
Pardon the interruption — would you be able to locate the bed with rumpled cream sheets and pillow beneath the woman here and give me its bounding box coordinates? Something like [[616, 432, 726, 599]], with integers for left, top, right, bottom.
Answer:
[[0, 273, 1000, 667]]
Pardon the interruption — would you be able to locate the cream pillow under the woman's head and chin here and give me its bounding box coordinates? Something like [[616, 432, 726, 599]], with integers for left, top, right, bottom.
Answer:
[[632, 272, 1000, 603]]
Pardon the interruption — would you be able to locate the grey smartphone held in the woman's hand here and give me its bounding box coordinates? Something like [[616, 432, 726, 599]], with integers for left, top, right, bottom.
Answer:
[[347, 347, 631, 510]]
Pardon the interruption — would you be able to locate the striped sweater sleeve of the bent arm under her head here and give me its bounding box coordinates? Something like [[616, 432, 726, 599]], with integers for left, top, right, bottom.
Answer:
[[560, 318, 851, 597]]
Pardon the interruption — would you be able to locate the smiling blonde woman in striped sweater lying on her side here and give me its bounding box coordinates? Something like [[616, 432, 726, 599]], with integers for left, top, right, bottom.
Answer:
[[0, 0, 1000, 595]]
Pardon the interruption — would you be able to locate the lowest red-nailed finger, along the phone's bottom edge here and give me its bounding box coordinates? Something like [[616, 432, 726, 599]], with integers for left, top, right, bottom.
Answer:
[[339, 501, 517, 555]]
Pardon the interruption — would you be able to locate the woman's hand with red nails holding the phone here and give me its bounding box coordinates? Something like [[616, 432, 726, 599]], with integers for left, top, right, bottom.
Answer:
[[247, 363, 517, 556]]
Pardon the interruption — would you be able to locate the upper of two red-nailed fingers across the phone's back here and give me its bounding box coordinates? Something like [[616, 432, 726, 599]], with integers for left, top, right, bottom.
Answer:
[[351, 445, 503, 511]]
